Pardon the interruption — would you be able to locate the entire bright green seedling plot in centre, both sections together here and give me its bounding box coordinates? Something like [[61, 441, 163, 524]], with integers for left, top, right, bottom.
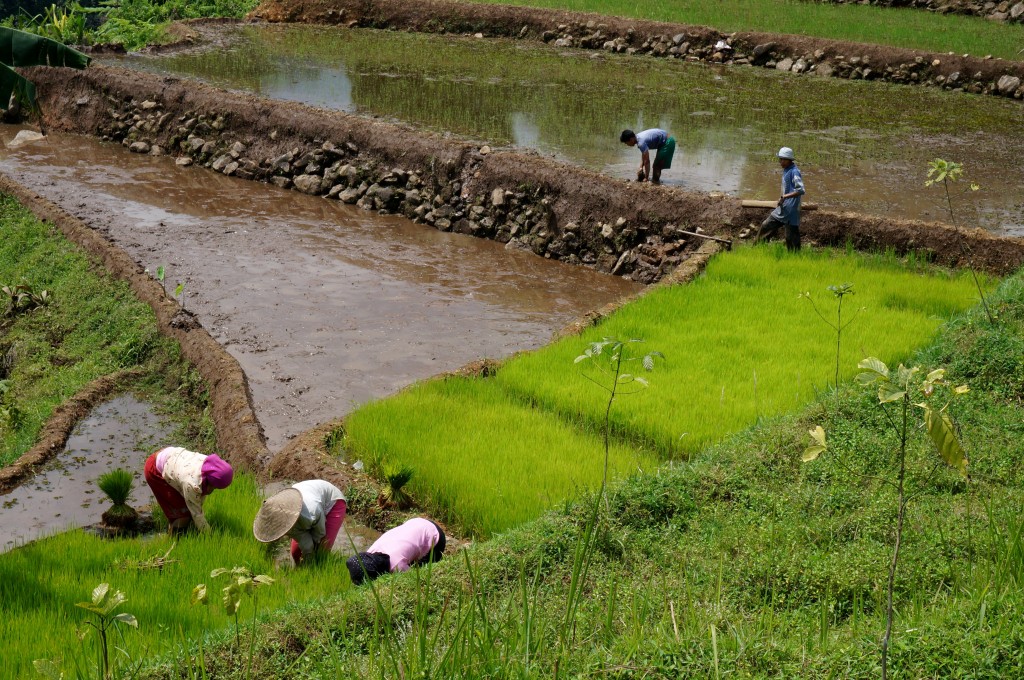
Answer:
[[345, 246, 977, 536]]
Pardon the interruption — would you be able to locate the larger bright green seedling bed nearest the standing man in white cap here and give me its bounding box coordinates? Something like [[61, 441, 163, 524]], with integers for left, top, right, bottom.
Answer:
[[495, 247, 972, 458]]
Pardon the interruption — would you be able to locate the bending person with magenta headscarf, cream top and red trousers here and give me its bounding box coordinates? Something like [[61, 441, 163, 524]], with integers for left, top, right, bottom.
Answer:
[[142, 447, 234, 533]]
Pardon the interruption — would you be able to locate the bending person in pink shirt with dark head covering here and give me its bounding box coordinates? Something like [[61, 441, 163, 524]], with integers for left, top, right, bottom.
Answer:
[[345, 517, 446, 586]]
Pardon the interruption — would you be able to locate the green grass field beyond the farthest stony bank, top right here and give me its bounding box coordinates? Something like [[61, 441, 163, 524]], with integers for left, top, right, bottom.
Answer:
[[462, 0, 1024, 59]]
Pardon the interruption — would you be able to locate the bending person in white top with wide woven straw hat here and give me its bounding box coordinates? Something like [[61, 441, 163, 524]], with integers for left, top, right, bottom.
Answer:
[[253, 479, 345, 564]]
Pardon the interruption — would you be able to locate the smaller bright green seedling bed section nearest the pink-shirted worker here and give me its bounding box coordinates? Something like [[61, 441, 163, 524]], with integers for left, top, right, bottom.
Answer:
[[345, 377, 656, 536]]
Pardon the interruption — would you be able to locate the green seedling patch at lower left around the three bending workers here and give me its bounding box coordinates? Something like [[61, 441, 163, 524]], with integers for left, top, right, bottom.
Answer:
[[0, 475, 350, 678]]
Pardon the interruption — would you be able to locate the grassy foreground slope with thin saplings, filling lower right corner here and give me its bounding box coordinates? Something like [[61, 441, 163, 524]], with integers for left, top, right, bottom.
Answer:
[[147, 262, 1024, 679]]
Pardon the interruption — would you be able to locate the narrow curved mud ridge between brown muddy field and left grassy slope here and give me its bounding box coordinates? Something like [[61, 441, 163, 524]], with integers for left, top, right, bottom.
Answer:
[[0, 173, 269, 472]]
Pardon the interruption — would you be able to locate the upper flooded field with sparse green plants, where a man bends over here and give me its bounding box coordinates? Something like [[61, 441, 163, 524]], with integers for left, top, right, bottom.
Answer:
[[102, 25, 1024, 236]]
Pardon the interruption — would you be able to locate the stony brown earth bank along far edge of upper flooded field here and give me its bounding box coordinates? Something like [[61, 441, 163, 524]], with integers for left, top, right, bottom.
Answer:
[[251, 0, 1024, 93]]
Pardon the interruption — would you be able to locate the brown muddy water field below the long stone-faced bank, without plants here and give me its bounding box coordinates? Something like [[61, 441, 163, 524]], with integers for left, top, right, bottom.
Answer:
[[0, 127, 639, 451]]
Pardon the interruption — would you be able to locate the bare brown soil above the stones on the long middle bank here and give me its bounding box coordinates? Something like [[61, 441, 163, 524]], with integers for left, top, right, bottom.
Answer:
[[31, 62, 1024, 274]]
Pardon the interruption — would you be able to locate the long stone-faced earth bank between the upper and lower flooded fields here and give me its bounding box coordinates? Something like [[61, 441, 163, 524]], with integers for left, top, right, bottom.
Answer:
[[31, 63, 1024, 274]]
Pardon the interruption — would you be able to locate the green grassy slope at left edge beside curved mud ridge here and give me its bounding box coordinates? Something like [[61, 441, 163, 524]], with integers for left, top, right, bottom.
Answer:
[[0, 191, 212, 466]]
